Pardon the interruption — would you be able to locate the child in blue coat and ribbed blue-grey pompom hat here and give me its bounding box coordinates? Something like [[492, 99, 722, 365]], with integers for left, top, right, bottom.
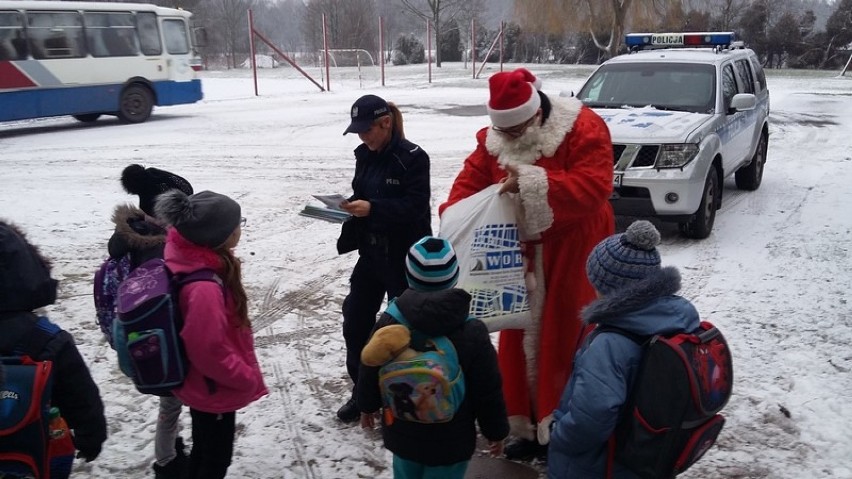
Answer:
[[547, 220, 699, 479]]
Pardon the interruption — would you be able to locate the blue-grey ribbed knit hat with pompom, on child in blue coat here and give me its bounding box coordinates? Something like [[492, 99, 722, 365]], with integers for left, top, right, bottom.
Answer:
[[586, 220, 660, 295]]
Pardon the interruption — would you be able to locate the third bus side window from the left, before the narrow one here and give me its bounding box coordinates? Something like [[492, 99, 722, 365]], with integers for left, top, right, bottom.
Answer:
[[85, 12, 139, 57]]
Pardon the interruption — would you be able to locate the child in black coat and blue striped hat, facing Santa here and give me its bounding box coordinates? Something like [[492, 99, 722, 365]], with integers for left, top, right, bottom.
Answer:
[[357, 236, 509, 479]]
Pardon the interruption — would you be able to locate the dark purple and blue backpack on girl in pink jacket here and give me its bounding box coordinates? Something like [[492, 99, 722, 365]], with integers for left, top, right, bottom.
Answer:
[[113, 258, 222, 396]]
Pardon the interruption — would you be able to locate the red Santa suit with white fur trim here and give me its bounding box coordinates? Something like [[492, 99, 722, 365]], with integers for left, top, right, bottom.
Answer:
[[439, 92, 615, 444]]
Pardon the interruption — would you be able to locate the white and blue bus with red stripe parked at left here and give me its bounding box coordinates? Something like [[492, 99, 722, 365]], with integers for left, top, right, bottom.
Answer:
[[0, 0, 202, 123]]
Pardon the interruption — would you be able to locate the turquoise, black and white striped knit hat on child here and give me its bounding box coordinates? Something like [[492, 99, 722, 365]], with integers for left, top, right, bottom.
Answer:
[[405, 236, 459, 291]]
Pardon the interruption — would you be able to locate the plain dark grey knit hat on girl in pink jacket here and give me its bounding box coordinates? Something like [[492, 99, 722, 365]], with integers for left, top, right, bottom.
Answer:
[[154, 190, 241, 248]]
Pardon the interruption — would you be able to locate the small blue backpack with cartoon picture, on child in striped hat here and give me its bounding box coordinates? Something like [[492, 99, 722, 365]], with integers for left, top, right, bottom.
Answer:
[[379, 301, 465, 425]]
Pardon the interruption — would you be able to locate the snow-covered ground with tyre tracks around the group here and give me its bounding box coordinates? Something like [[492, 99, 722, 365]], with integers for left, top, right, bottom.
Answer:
[[0, 64, 852, 479]]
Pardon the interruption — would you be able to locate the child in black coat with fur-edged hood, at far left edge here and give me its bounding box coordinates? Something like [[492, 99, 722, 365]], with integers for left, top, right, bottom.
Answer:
[[0, 221, 107, 472]]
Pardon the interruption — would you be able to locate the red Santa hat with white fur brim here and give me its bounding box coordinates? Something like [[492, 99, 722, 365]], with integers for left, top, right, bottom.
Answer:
[[488, 68, 541, 128]]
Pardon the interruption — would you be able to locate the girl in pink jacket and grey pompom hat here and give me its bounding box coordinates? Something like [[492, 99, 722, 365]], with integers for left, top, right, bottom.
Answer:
[[155, 190, 268, 479]]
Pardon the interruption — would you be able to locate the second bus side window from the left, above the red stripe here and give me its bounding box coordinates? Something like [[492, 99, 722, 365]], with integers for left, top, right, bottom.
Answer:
[[27, 12, 85, 60]]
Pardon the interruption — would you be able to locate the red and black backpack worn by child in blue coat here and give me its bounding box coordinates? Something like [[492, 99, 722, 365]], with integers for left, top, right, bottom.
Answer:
[[595, 321, 734, 479]]
